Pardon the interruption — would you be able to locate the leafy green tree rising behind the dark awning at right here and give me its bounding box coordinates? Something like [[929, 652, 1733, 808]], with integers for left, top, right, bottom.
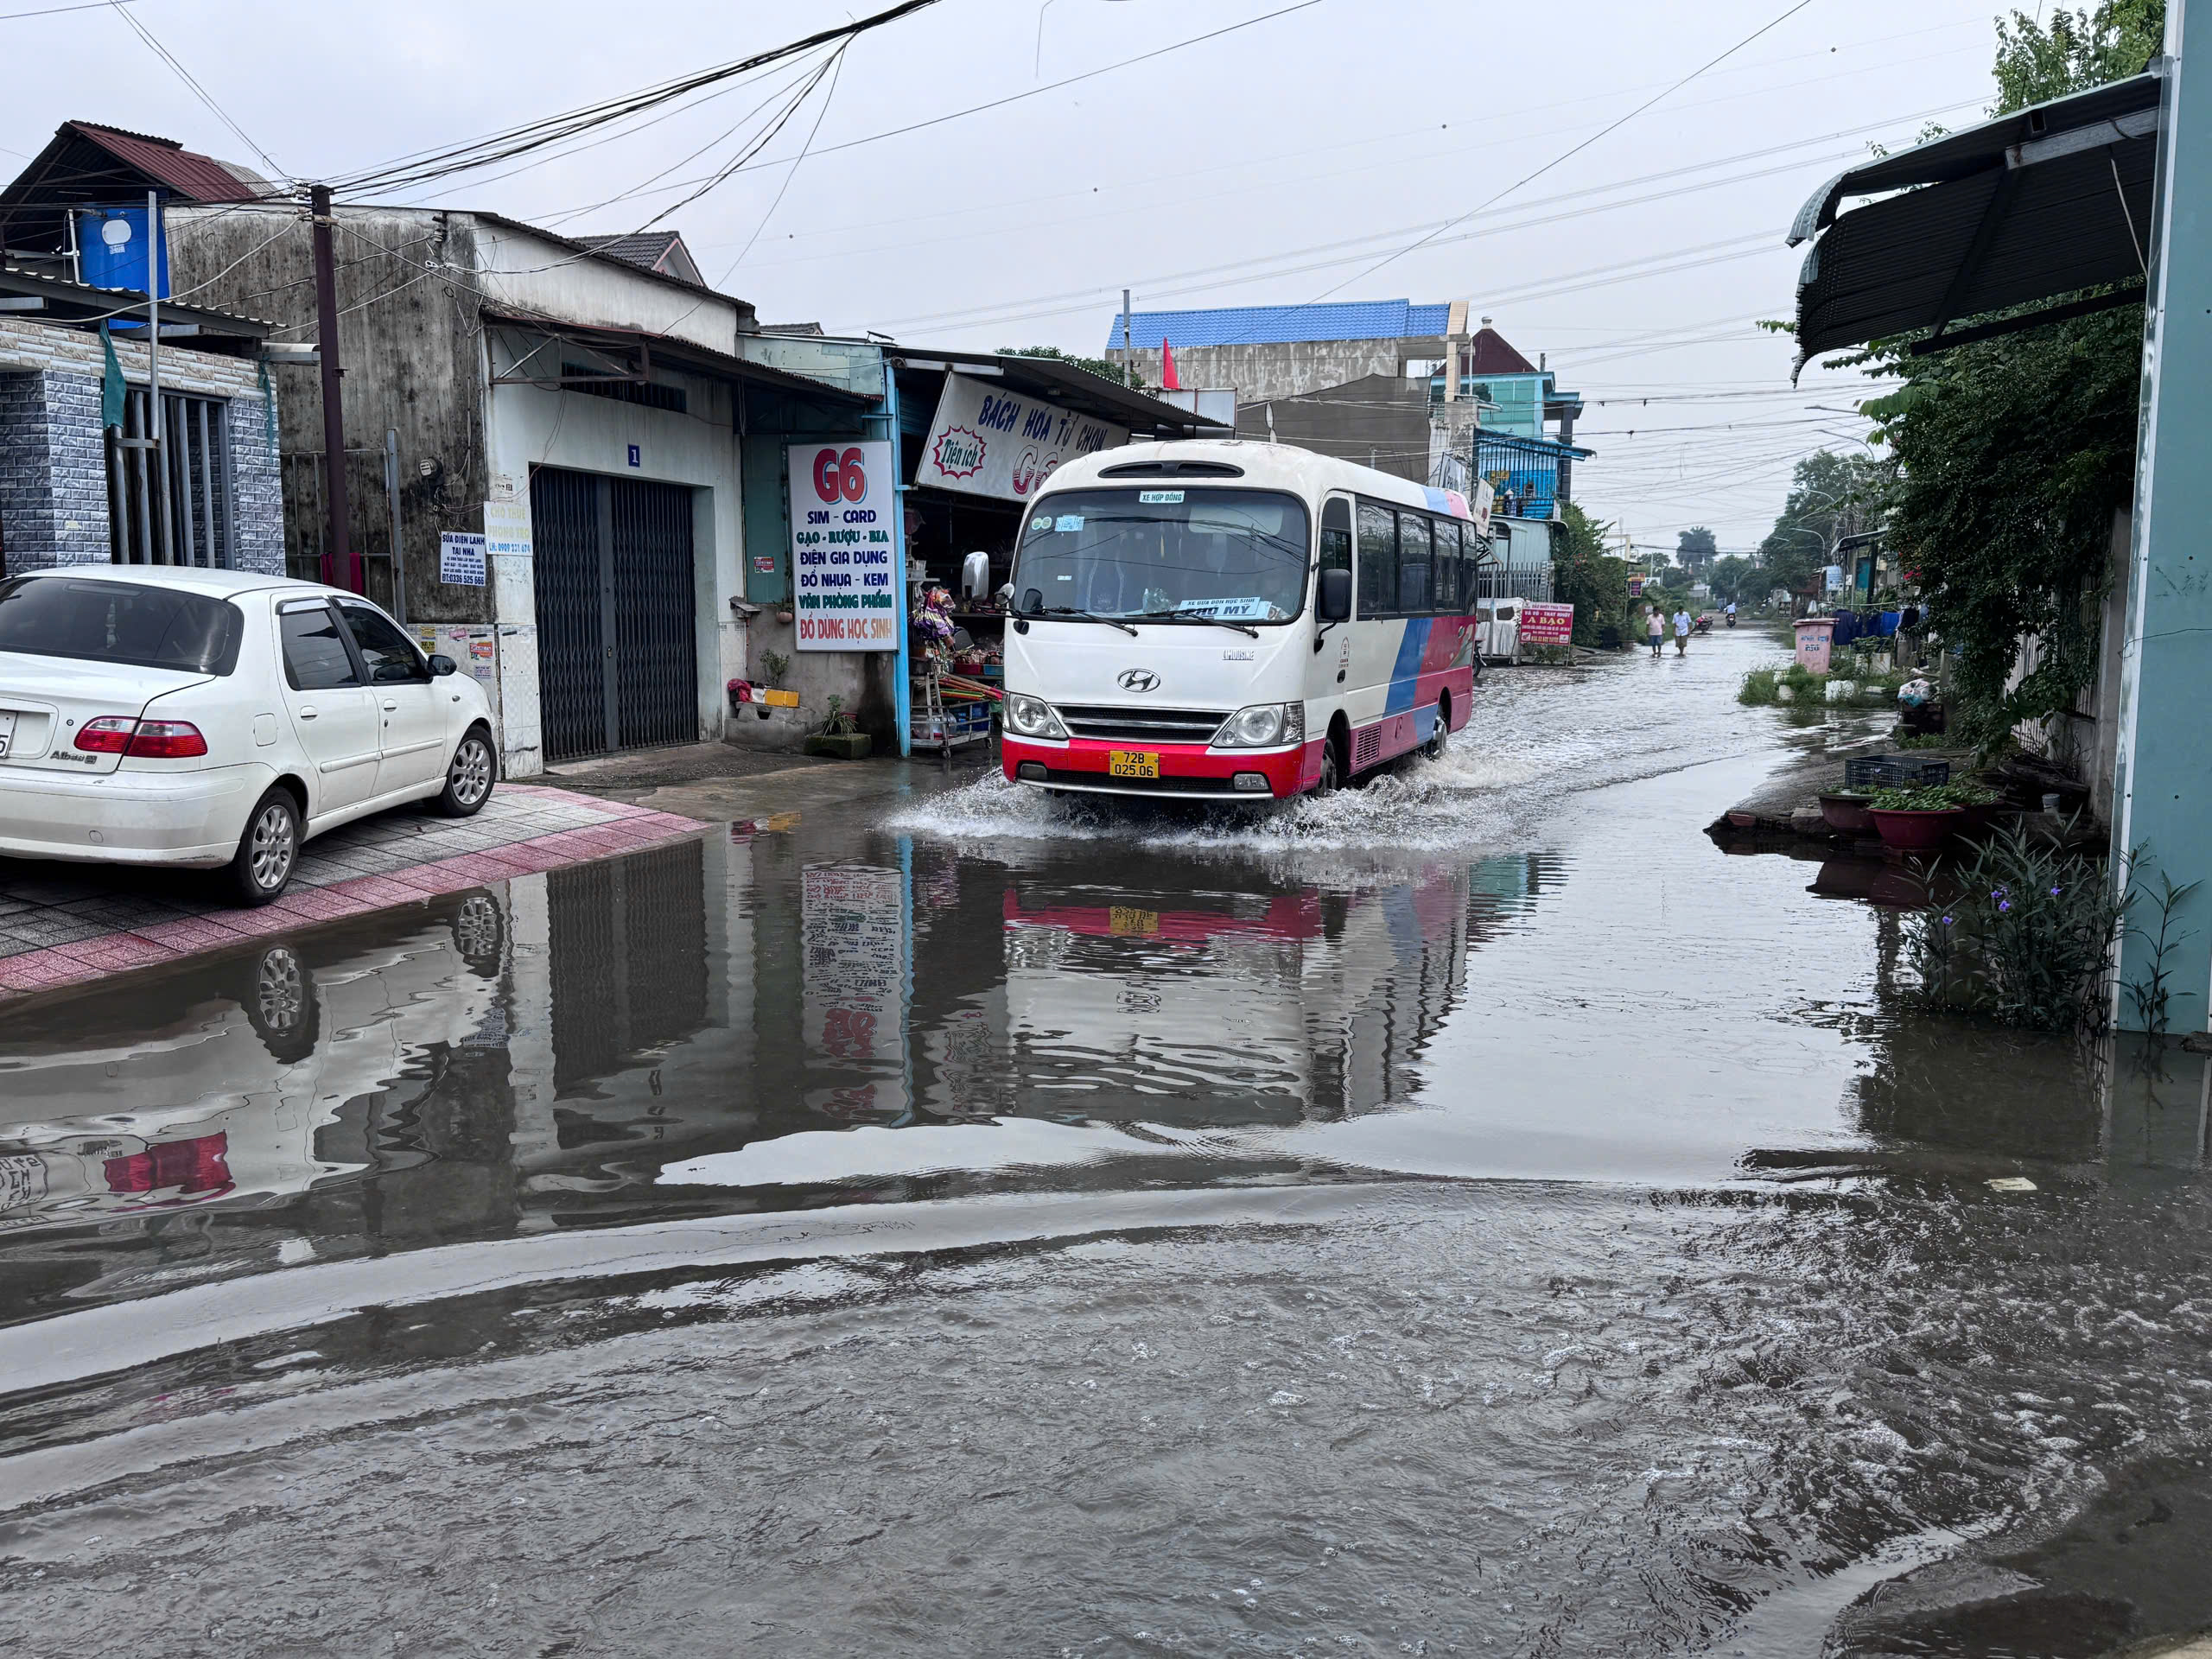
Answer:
[[1831, 0, 2165, 746]]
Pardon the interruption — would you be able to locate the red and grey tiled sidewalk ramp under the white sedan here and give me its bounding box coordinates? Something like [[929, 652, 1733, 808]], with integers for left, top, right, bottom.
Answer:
[[0, 783, 699, 1002]]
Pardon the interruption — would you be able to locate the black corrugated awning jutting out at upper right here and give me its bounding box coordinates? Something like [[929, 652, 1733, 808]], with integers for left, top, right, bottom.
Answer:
[[1789, 67, 2164, 367]]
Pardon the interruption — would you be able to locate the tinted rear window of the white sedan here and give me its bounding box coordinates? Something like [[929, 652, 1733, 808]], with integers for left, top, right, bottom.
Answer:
[[0, 575, 245, 675]]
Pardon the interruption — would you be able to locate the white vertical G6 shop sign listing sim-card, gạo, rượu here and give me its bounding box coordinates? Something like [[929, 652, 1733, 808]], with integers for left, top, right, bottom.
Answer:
[[783, 440, 898, 651]]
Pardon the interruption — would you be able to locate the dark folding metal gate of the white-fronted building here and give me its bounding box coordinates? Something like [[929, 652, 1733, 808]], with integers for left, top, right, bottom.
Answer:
[[531, 467, 699, 761]]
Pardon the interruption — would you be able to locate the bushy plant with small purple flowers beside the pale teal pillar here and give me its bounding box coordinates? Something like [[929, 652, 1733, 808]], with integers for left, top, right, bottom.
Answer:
[[1907, 827, 2133, 1031]]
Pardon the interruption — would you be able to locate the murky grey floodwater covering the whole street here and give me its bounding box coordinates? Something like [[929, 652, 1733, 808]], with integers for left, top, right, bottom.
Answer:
[[0, 632, 2212, 1655]]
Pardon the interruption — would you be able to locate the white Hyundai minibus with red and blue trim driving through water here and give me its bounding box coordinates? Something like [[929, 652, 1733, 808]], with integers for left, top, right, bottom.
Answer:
[[1004, 440, 1482, 801]]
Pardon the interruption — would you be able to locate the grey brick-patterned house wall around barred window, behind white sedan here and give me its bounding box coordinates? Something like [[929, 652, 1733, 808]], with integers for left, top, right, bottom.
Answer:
[[0, 316, 283, 575]]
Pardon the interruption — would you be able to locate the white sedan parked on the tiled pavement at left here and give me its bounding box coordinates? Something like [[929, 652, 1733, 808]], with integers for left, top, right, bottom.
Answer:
[[0, 564, 498, 905]]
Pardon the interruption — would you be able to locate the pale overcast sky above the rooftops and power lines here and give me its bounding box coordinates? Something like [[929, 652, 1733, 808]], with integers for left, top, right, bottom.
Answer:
[[0, 0, 2008, 549]]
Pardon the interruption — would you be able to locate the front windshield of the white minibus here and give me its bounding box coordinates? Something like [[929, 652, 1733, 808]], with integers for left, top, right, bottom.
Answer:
[[1013, 489, 1310, 624]]
